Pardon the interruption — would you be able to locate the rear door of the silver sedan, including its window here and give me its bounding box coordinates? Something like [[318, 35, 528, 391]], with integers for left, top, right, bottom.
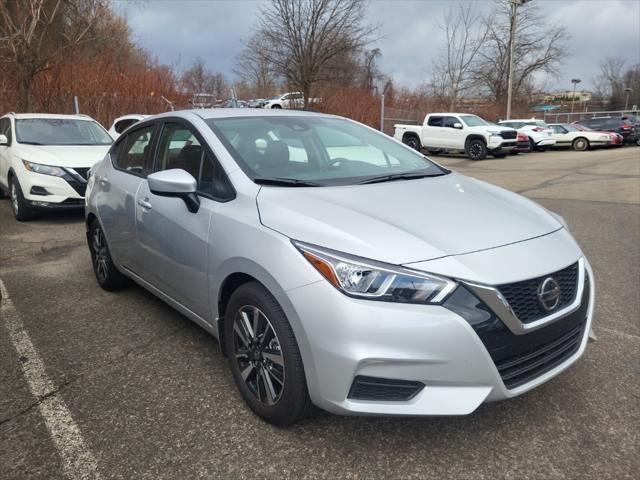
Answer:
[[95, 123, 156, 273]]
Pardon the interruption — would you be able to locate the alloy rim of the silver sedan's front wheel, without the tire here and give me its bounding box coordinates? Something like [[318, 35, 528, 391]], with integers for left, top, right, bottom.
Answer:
[[233, 305, 285, 405]]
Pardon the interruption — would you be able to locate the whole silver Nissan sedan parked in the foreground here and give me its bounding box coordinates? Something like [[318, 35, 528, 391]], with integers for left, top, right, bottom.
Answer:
[[86, 109, 594, 425]]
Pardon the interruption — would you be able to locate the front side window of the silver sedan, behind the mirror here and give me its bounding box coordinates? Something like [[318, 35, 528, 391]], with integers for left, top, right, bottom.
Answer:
[[158, 123, 233, 200]]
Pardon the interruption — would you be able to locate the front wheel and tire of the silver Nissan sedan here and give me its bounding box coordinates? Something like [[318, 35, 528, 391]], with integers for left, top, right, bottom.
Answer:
[[224, 282, 312, 426]]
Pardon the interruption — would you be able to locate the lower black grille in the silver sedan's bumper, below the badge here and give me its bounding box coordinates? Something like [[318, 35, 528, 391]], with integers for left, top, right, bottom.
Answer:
[[496, 321, 585, 389]]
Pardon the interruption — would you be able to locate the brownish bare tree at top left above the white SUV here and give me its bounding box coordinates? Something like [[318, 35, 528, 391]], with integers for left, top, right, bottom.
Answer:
[[0, 0, 106, 111]]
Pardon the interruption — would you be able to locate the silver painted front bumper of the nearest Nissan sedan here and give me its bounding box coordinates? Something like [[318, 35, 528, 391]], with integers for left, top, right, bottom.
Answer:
[[278, 258, 594, 415]]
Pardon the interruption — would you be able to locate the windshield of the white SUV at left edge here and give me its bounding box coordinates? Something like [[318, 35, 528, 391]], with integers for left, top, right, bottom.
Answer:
[[16, 118, 113, 145]]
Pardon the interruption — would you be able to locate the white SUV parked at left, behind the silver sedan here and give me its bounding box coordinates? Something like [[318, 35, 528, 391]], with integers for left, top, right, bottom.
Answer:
[[0, 113, 113, 221]]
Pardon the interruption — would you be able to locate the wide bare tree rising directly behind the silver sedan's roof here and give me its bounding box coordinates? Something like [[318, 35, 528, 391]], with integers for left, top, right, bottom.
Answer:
[[256, 0, 377, 107]]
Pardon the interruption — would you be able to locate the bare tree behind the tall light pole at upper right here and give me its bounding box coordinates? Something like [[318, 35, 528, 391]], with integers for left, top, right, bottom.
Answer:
[[473, 0, 568, 102]]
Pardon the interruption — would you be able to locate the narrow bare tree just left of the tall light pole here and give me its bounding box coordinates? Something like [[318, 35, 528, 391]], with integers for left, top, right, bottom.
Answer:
[[431, 3, 490, 111]]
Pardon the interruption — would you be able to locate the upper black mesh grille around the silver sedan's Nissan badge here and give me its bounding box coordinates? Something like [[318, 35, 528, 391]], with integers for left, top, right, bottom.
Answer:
[[498, 263, 578, 323]]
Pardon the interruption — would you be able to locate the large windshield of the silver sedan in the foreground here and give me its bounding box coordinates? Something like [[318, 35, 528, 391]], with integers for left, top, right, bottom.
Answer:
[[207, 116, 448, 186]]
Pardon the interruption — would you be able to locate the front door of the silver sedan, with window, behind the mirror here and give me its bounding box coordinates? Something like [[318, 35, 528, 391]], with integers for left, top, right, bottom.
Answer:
[[135, 119, 233, 319]]
